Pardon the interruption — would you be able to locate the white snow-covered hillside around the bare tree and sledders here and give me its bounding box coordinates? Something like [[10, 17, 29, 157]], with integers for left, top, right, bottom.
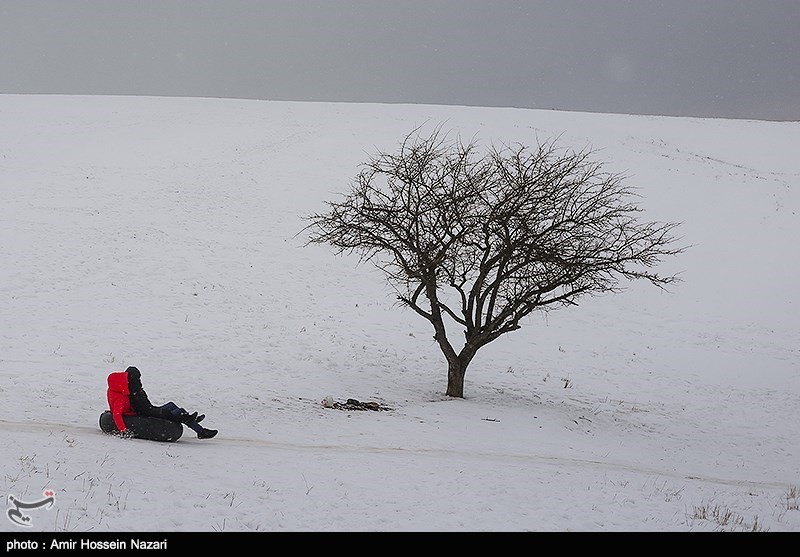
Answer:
[[0, 95, 800, 535]]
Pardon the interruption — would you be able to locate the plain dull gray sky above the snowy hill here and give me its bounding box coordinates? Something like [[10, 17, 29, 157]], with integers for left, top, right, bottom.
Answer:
[[0, 0, 800, 120]]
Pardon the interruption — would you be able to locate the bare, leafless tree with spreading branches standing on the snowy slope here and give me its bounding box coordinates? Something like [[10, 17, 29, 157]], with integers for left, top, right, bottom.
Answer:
[[304, 129, 682, 398]]
